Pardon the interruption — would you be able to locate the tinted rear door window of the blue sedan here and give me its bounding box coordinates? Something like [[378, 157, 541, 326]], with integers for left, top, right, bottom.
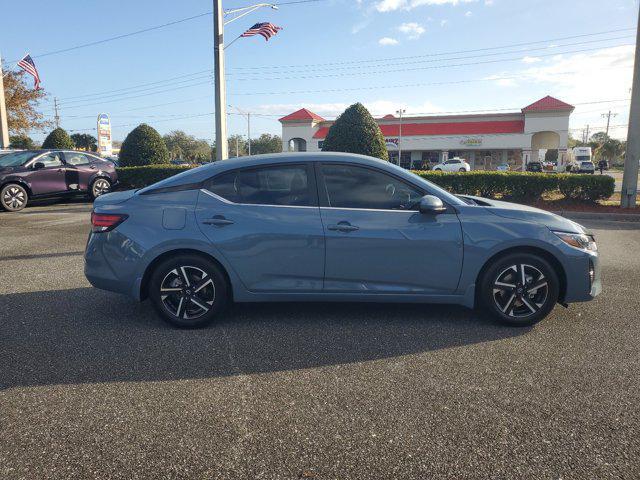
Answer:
[[206, 165, 315, 206]]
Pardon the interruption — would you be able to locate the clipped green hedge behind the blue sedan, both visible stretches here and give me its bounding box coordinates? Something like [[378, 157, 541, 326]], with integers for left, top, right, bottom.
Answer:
[[118, 165, 615, 202]]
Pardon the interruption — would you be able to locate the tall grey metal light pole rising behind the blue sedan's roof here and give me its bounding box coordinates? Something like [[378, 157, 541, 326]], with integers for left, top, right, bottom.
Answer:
[[213, 0, 229, 160]]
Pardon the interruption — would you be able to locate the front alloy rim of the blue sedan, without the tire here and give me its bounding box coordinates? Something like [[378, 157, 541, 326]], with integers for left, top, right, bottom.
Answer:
[[493, 263, 549, 318]]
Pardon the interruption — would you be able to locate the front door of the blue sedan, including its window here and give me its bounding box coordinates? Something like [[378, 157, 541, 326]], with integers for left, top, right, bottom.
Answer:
[[318, 163, 462, 294]]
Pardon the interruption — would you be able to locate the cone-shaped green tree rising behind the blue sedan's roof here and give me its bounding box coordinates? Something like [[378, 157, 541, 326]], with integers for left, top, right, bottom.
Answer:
[[322, 103, 389, 160]]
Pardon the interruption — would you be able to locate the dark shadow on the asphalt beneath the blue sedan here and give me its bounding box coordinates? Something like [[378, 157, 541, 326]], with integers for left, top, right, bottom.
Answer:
[[0, 288, 528, 389]]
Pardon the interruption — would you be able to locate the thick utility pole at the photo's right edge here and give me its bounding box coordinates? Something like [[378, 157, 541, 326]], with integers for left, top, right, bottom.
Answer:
[[620, 3, 640, 208]]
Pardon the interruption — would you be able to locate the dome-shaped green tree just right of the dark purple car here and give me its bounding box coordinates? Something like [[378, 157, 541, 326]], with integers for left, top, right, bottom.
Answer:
[[118, 123, 169, 167]]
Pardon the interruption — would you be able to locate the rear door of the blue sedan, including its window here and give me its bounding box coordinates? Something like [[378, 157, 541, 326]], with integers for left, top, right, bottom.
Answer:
[[196, 162, 324, 292]]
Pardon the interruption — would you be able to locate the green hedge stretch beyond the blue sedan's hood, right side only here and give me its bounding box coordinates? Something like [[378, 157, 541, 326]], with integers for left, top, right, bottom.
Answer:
[[414, 171, 615, 202]]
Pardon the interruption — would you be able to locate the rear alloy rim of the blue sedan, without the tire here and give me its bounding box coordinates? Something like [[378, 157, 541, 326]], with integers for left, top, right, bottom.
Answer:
[[160, 265, 216, 320]]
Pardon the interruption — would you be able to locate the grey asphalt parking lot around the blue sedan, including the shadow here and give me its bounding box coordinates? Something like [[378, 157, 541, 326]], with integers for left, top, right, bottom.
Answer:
[[0, 203, 640, 479]]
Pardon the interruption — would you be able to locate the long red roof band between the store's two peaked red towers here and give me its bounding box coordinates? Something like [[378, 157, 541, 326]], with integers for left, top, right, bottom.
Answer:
[[313, 120, 524, 139]]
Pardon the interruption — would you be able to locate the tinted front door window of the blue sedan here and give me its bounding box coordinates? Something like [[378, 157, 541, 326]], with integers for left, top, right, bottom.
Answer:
[[321, 164, 423, 210]]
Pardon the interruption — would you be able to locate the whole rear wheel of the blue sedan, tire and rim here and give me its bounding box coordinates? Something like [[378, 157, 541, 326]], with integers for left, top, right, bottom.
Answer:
[[148, 255, 229, 328]]
